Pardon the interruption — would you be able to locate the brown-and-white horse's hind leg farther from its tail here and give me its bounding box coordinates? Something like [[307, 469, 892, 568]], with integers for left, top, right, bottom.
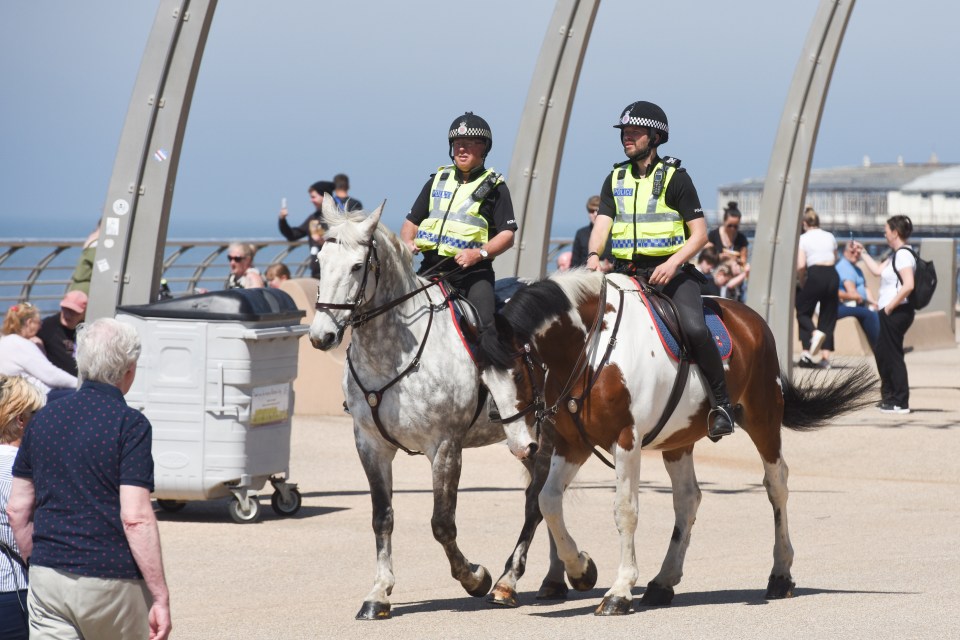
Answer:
[[640, 445, 702, 607]]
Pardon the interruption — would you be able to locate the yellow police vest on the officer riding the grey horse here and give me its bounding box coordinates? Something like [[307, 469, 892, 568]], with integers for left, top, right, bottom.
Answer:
[[416, 165, 503, 256]]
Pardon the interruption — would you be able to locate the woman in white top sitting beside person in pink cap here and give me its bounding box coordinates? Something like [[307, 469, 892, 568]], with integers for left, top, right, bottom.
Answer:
[[0, 302, 77, 394]]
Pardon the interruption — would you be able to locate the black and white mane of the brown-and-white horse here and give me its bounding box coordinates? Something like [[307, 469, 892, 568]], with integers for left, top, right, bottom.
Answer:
[[501, 269, 603, 350]]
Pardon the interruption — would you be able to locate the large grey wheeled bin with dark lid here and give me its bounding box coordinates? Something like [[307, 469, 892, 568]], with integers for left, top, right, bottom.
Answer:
[[116, 289, 308, 522]]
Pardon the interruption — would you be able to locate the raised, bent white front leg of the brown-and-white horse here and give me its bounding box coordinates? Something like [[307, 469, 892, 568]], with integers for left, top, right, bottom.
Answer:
[[540, 455, 597, 591]]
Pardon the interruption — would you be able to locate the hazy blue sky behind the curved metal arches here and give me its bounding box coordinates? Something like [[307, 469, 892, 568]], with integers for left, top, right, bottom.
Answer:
[[0, 0, 960, 238]]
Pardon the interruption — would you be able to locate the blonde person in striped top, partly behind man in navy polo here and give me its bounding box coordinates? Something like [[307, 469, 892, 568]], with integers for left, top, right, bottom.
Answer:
[[0, 376, 43, 640]]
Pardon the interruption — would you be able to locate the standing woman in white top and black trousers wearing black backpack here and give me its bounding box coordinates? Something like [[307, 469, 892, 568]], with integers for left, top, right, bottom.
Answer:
[[863, 216, 917, 413]]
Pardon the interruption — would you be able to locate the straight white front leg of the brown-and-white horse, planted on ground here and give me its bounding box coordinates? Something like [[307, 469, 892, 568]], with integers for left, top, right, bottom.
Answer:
[[594, 449, 640, 616]]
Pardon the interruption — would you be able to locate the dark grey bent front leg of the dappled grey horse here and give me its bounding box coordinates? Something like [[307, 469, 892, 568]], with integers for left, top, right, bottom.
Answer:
[[430, 440, 493, 598]]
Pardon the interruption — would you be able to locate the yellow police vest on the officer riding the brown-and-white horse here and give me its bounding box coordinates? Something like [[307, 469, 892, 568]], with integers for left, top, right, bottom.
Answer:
[[610, 157, 687, 260]]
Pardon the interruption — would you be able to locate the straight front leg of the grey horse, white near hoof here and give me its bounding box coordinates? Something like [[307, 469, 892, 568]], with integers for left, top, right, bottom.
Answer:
[[354, 428, 396, 620]]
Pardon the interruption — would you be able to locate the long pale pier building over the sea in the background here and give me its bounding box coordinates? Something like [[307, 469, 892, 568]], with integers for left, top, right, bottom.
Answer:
[[717, 156, 960, 236]]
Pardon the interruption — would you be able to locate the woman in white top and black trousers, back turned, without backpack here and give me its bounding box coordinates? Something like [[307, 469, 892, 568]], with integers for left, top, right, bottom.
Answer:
[[797, 207, 840, 369]]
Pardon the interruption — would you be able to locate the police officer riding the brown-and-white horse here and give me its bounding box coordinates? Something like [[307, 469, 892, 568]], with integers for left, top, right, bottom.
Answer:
[[587, 101, 734, 439]]
